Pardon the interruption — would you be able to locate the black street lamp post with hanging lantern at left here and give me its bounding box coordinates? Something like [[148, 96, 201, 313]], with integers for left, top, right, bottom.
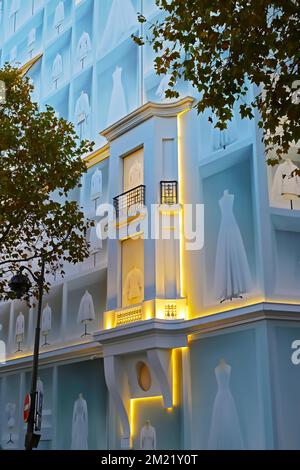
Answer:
[[10, 259, 45, 450]]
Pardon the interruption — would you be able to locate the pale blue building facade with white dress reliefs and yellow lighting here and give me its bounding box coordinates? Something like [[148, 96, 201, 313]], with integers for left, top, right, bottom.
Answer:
[[0, 0, 300, 450]]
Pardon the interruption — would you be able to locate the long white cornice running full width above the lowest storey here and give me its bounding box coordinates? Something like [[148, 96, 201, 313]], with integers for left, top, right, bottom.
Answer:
[[0, 302, 300, 374]]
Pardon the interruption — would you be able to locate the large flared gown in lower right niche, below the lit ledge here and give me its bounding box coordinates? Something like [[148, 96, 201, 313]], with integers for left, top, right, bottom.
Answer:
[[208, 359, 244, 450]]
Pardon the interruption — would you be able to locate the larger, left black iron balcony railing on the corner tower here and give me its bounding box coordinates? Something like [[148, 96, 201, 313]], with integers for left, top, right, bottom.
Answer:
[[113, 184, 146, 219]]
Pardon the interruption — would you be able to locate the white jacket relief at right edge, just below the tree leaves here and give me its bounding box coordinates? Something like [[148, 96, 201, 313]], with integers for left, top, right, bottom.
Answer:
[[271, 159, 300, 209]]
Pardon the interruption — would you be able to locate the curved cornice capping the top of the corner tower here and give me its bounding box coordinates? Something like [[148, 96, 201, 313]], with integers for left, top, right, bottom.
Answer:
[[100, 96, 195, 142]]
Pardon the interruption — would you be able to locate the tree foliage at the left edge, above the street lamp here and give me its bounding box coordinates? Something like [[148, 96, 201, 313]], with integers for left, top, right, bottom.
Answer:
[[0, 65, 92, 297]]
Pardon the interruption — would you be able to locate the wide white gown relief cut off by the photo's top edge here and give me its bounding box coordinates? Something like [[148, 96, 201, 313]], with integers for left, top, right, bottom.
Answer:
[[100, 0, 138, 54]]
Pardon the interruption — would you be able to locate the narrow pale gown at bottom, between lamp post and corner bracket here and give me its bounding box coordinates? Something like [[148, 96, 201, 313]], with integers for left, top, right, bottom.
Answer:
[[71, 393, 89, 450]]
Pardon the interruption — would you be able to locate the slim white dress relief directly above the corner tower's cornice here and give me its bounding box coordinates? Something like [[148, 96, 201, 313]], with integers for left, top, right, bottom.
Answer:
[[107, 67, 127, 125]]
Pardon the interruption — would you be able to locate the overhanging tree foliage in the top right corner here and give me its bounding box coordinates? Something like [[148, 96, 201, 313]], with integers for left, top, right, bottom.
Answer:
[[135, 0, 300, 164]]
